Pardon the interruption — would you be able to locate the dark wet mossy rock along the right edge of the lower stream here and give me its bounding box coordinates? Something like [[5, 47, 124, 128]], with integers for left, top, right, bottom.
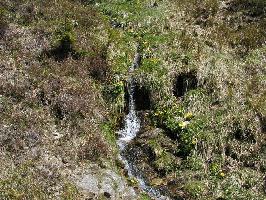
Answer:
[[123, 127, 181, 198]]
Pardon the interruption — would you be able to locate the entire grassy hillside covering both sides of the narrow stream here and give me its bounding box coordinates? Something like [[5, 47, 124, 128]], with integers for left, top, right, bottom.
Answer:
[[0, 0, 266, 199]]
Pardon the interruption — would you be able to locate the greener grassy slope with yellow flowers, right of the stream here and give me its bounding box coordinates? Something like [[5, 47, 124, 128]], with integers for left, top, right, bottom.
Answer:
[[95, 0, 266, 199]]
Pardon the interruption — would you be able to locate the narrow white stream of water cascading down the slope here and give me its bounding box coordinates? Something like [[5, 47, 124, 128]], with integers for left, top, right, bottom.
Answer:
[[117, 49, 169, 200]]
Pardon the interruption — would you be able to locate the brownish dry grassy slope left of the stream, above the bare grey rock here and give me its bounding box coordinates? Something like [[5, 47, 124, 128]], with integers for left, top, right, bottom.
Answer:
[[0, 0, 122, 199]]
